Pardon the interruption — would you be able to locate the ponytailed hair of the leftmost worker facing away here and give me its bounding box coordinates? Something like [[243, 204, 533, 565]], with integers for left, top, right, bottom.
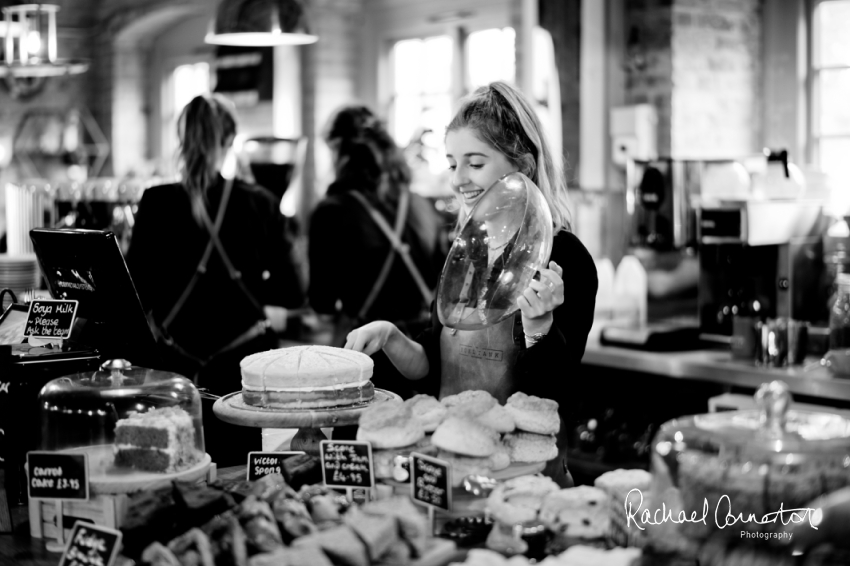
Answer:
[[177, 95, 236, 225]]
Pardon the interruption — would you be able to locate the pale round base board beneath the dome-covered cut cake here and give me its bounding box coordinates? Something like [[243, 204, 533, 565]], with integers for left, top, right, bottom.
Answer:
[[63, 444, 212, 495]]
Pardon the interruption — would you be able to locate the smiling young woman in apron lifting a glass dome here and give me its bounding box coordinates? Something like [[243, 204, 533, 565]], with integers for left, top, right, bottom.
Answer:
[[345, 82, 597, 486]]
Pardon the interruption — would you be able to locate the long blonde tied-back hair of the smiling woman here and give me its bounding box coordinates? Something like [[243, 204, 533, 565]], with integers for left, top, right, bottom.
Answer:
[[446, 81, 570, 232]]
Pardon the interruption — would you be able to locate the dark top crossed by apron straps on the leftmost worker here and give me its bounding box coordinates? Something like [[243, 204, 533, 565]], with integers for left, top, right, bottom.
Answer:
[[127, 177, 304, 364]]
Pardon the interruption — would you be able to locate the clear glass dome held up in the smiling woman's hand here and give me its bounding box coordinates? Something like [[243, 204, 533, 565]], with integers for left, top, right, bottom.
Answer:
[[437, 172, 554, 330]]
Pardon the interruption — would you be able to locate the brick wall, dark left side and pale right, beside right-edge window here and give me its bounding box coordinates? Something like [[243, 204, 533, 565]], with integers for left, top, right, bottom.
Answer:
[[625, 0, 762, 159]]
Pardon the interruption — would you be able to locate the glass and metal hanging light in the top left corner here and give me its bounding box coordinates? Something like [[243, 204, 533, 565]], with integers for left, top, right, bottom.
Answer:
[[0, 4, 89, 78]]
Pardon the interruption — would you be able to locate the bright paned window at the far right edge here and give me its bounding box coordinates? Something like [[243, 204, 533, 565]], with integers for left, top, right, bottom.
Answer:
[[812, 0, 850, 180]]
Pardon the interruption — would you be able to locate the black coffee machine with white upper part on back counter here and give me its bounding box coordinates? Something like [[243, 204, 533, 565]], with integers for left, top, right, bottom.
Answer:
[[697, 199, 827, 342]]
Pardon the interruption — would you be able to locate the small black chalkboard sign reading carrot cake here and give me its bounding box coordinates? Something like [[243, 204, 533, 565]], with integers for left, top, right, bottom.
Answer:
[[27, 452, 89, 499]]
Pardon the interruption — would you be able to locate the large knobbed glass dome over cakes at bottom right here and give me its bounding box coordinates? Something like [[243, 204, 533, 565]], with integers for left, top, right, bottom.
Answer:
[[643, 381, 850, 544]]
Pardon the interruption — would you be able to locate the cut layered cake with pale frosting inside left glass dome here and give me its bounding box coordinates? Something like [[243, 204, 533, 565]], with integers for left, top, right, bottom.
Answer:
[[115, 407, 201, 472]]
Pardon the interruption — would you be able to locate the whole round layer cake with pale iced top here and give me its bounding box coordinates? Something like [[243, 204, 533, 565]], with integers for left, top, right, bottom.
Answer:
[[240, 346, 375, 409]]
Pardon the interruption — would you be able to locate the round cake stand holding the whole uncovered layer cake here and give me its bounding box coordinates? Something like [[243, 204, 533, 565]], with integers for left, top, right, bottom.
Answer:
[[213, 388, 401, 457]]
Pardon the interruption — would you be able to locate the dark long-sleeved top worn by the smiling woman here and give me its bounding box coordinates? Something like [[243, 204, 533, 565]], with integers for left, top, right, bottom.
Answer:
[[414, 231, 598, 407]]
